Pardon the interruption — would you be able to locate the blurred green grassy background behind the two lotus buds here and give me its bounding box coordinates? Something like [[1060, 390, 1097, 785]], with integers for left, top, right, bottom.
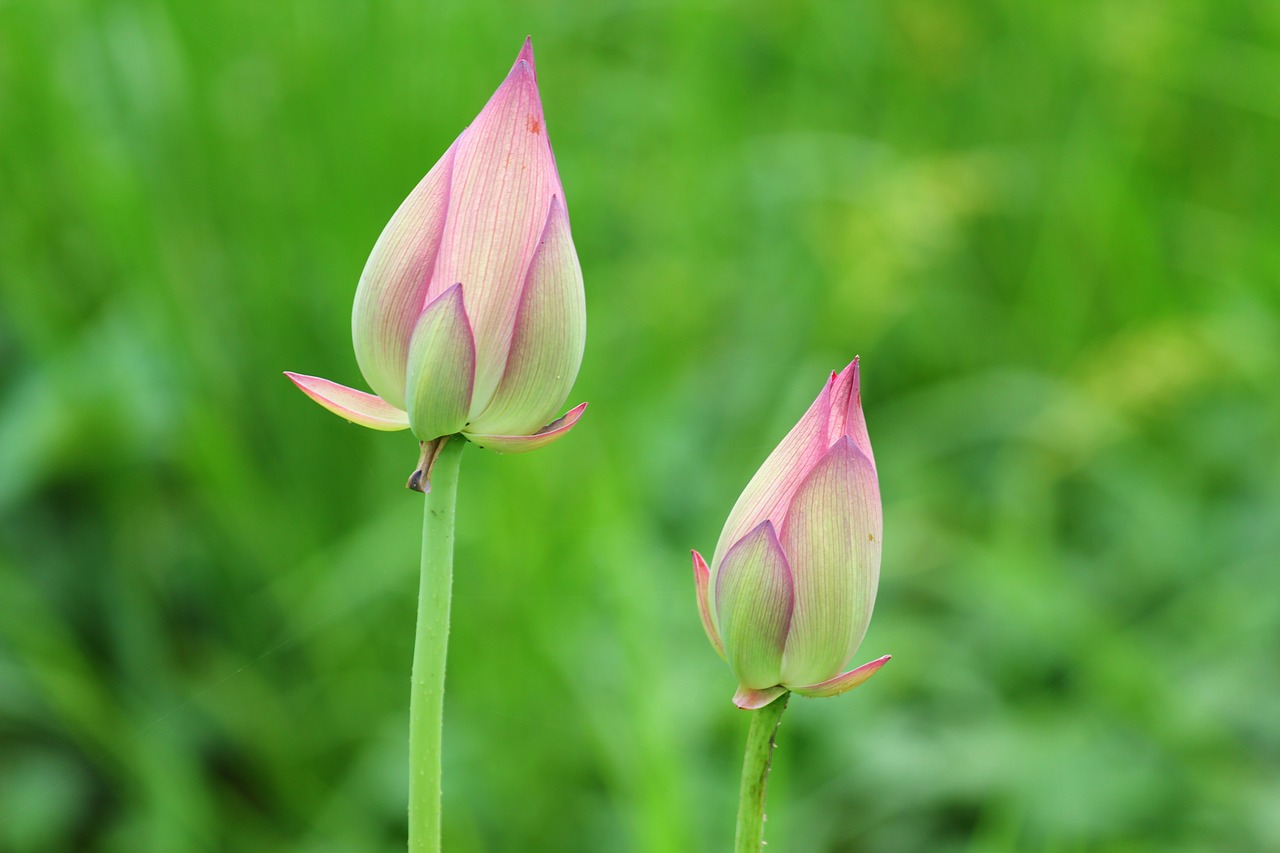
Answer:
[[0, 0, 1280, 853]]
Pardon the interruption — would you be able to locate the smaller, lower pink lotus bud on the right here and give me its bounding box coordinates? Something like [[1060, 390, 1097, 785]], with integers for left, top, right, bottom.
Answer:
[[694, 359, 888, 708]]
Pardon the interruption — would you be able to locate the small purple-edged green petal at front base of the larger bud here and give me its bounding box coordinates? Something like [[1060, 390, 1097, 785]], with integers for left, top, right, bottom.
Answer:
[[406, 284, 476, 442]]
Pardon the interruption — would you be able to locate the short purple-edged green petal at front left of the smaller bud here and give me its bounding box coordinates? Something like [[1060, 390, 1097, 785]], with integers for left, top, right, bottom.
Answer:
[[712, 521, 792, 690]]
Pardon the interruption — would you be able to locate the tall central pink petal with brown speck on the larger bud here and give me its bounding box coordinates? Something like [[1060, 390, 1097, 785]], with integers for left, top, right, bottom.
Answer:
[[431, 44, 563, 406]]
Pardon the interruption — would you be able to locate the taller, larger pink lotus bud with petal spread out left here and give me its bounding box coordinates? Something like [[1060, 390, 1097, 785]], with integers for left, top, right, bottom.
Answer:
[[287, 41, 586, 452]]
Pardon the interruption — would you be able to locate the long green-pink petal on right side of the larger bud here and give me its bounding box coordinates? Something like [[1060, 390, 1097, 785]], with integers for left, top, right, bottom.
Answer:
[[472, 197, 586, 435]]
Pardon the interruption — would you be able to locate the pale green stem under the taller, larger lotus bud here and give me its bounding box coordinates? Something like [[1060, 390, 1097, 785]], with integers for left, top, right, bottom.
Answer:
[[408, 437, 466, 853]]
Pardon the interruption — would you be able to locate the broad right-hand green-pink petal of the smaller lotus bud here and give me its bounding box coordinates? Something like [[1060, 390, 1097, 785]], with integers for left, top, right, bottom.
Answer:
[[781, 435, 881, 685]]
